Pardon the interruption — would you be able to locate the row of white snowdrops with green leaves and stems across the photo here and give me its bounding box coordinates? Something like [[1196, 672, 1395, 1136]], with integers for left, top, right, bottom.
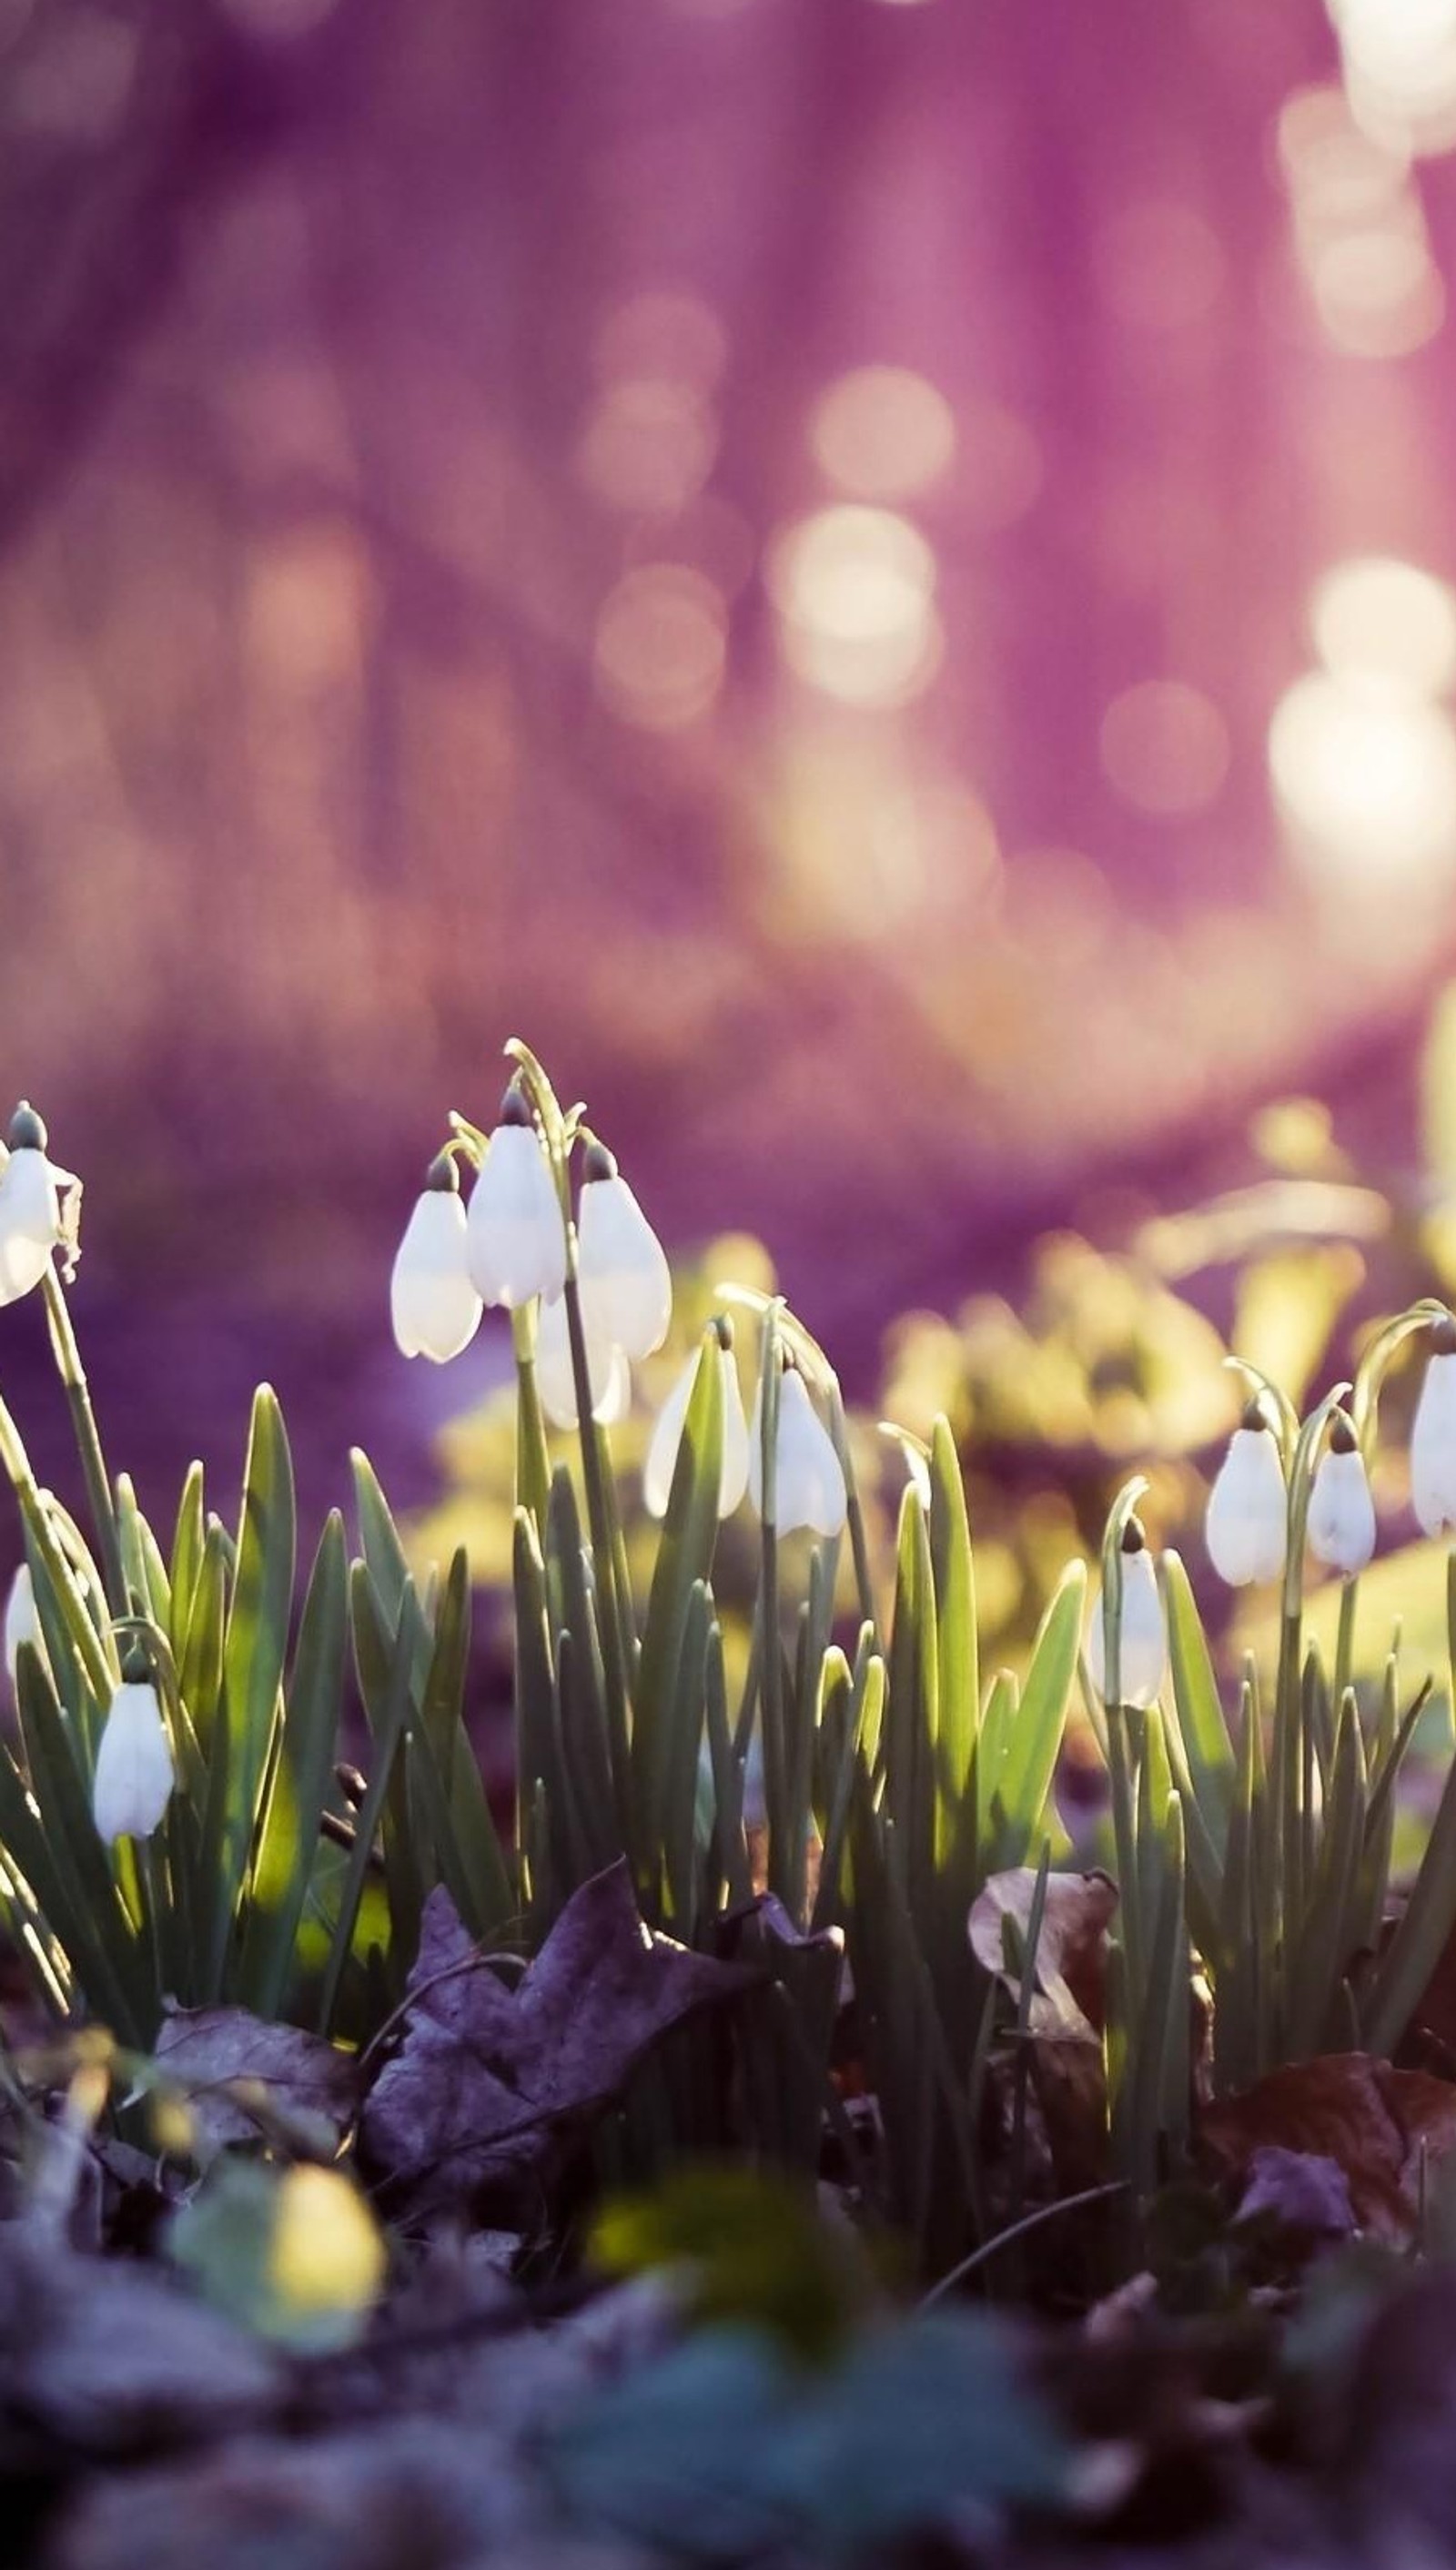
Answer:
[[0, 1044, 1456, 2270]]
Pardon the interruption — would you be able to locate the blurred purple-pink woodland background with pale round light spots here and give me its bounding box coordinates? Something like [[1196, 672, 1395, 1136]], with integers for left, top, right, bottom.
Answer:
[[0, 0, 1456, 1509]]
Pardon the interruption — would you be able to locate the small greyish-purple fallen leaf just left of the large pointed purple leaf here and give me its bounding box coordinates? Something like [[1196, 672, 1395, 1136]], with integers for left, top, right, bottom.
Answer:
[[154, 2008, 359, 2151]]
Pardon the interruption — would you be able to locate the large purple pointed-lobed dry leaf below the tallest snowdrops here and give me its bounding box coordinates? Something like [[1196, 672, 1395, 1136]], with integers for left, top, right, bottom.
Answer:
[[359, 1863, 763, 2218]]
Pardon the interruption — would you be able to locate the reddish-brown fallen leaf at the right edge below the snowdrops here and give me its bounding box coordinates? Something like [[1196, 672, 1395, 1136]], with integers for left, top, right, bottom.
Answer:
[[1197, 2053, 1456, 2246]]
